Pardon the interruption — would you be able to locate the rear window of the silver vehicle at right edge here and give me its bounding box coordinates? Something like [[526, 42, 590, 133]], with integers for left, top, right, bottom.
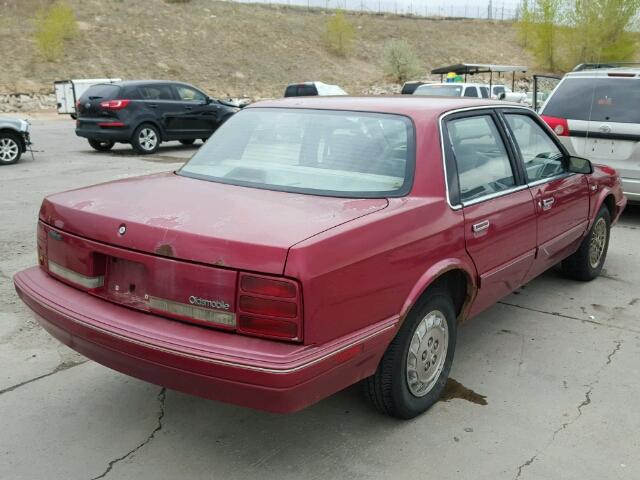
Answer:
[[542, 77, 640, 123]]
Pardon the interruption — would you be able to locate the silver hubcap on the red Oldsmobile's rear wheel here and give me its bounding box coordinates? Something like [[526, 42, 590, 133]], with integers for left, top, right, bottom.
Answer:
[[407, 310, 449, 397]]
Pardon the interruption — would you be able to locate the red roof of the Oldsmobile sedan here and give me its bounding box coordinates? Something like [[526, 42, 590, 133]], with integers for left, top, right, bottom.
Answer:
[[246, 95, 522, 118]]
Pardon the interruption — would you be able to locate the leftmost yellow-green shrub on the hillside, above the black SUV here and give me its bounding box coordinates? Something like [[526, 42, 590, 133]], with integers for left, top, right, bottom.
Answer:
[[34, 0, 78, 61]]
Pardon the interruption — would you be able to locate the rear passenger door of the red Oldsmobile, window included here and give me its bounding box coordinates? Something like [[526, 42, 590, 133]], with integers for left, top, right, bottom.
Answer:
[[444, 109, 536, 314]]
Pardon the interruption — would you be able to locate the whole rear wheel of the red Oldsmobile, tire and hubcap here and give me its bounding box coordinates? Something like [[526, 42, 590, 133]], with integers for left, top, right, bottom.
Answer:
[[363, 289, 456, 419]]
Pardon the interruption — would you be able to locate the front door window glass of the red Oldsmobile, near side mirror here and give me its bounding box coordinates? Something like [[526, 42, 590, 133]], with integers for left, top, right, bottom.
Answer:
[[505, 113, 566, 182]]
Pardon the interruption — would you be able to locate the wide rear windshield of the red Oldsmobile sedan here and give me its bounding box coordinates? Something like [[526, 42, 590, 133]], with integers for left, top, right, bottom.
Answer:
[[178, 108, 415, 198]]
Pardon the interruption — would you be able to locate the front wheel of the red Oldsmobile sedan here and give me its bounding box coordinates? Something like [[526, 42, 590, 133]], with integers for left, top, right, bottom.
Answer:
[[561, 205, 611, 282]]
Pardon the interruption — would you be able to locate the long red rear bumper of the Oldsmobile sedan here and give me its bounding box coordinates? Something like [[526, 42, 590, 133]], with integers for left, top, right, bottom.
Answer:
[[14, 267, 398, 413]]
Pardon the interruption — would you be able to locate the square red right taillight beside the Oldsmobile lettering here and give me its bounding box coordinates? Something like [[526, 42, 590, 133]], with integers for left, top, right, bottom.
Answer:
[[236, 273, 302, 342]]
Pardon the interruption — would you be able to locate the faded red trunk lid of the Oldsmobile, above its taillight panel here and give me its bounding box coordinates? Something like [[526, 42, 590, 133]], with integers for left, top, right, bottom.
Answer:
[[40, 173, 387, 275]]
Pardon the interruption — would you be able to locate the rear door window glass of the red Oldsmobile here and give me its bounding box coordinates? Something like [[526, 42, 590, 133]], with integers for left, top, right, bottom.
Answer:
[[447, 115, 515, 203]]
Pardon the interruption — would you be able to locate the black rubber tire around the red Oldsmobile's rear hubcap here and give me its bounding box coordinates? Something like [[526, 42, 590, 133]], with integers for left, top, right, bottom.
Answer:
[[362, 289, 456, 419]]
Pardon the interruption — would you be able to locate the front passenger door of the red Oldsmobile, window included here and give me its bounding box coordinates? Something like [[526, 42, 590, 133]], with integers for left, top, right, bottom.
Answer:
[[504, 109, 589, 280]]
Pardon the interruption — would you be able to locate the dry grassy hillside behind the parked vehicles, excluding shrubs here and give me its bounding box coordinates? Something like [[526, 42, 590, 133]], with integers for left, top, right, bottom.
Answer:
[[0, 0, 531, 97]]
